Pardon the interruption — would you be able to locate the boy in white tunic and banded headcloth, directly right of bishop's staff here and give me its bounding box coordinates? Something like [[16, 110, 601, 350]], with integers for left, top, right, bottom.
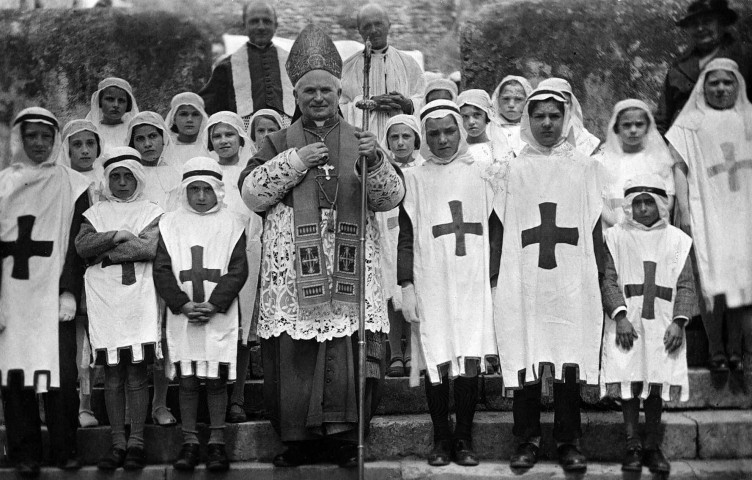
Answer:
[[398, 100, 497, 466]]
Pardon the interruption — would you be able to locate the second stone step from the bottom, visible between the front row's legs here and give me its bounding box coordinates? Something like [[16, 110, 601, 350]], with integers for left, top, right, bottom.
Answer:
[[0, 410, 752, 464]]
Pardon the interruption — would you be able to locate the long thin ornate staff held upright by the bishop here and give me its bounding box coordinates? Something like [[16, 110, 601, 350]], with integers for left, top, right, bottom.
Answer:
[[358, 39, 371, 480]]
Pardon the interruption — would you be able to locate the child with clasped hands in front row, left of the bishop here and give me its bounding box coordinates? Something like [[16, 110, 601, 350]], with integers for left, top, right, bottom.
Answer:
[[154, 157, 248, 472]]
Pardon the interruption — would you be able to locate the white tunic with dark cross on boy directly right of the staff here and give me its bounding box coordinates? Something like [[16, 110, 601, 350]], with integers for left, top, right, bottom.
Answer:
[[403, 154, 497, 383]]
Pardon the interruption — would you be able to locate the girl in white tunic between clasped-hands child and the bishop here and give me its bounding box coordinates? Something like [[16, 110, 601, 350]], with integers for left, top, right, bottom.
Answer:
[[206, 110, 264, 423]]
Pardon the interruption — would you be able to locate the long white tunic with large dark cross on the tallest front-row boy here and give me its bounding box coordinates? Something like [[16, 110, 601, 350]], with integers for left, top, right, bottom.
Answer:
[[494, 143, 603, 388]]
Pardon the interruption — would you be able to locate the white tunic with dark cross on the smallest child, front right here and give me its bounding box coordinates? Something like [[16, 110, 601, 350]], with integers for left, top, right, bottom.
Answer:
[[600, 223, 692, 402]]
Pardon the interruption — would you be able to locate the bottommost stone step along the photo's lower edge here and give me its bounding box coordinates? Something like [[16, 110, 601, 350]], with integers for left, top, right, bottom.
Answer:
[[0, 458, 752, 480]]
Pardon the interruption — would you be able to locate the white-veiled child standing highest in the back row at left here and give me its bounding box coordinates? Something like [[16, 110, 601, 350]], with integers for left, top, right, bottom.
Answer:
[[86, 77, 138, 148]]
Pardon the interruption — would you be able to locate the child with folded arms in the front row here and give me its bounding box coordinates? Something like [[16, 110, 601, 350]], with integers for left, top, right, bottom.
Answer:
[[76, 147, 162, 470]]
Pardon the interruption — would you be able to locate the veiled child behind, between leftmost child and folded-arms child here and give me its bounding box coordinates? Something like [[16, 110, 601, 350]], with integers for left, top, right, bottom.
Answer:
[[60, 120, 104, 428]]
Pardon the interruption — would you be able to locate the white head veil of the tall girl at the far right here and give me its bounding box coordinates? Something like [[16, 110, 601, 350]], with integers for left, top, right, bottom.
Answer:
[[674, 58, 752, 141]]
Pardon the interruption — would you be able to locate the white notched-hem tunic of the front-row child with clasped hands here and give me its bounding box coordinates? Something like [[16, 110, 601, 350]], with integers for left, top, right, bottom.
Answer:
[[159, 208, 245, 381]]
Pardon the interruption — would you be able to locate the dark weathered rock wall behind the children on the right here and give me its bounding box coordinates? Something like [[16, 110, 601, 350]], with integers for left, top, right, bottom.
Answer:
[[460, 0, 752, 139]]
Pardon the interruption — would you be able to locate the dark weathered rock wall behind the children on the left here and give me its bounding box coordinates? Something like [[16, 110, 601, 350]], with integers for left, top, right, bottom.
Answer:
[[0, 9, 211, 167]]
